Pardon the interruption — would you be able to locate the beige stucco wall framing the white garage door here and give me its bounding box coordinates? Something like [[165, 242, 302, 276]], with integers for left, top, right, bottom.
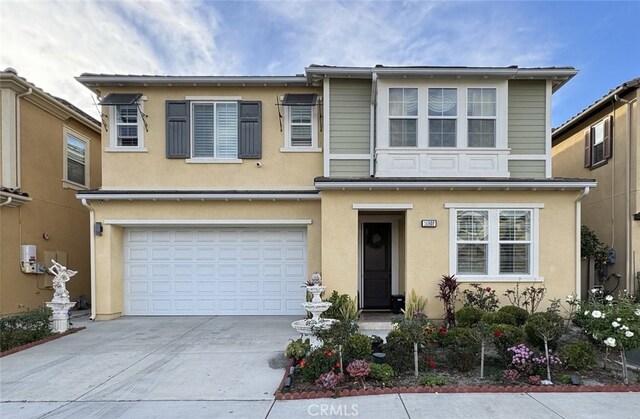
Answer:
[[92, 200, 321, 320]]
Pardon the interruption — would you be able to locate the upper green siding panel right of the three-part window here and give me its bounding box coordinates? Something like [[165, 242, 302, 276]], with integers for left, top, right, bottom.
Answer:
[[509, 80, 546, 154]]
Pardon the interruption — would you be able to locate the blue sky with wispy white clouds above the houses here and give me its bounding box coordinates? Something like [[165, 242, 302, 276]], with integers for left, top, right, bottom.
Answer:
[[0, 0, 640, 126]]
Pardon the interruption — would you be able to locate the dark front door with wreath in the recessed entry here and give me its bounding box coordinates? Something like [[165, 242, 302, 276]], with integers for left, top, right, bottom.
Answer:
[[362, 223, 391, 308]]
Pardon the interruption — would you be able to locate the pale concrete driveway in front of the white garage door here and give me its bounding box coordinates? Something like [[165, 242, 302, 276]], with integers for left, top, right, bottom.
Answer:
[[0, 316, 298, 418]]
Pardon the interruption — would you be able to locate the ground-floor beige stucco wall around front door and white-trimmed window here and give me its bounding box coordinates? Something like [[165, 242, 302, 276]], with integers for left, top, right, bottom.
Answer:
[[322, 191, 579, 318]]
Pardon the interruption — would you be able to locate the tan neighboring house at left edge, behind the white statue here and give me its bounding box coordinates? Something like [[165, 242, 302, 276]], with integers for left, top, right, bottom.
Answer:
[[0, 68, 101, 315]]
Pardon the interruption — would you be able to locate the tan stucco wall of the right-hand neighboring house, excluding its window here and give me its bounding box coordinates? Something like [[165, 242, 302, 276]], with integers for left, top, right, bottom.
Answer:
[[553, 90, 640, 292]]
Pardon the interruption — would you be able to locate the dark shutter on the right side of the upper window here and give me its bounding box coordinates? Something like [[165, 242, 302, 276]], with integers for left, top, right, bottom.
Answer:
[[238, 102, 262, 159]]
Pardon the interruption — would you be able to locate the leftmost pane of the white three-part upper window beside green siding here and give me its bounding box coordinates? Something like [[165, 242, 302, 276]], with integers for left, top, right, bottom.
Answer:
[[389, 88, 418, 147]]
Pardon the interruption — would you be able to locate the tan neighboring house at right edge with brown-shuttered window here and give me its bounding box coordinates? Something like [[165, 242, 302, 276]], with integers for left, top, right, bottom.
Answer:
[[553, 78, 640, 293]]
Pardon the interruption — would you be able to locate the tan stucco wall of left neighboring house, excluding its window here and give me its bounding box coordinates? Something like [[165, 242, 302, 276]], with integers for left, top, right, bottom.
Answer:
[[0, 96, 101, 315]]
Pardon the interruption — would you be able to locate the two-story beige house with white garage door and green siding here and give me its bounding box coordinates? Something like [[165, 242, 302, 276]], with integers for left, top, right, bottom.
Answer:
[[77, 66, 596, 320]]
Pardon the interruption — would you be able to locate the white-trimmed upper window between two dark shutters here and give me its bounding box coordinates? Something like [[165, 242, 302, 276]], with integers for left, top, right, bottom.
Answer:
[[191, 102, 238, 159]]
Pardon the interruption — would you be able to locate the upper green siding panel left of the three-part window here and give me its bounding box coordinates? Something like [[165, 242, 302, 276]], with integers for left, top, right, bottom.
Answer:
[[329, 79, 371, 154]]
